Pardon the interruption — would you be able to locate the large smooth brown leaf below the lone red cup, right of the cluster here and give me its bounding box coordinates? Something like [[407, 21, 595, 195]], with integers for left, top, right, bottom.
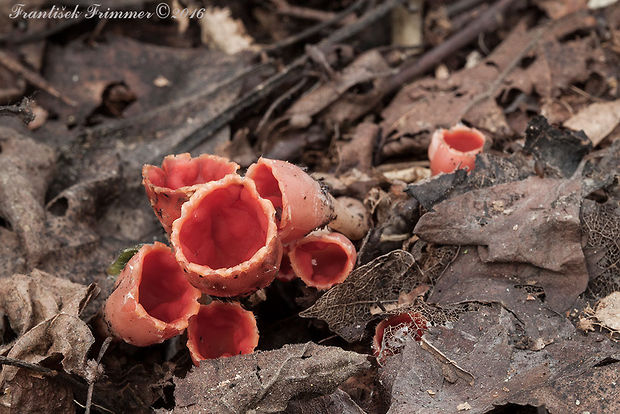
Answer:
[[415, 177, 588, 311]]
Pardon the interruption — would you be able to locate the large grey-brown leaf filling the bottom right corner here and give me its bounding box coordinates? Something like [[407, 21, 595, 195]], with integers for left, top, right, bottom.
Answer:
[[379, 305, 620, 414]]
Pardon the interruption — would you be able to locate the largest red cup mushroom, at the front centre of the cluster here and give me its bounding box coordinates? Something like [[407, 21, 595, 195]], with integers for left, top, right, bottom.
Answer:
[[170, 175, 282, 297]]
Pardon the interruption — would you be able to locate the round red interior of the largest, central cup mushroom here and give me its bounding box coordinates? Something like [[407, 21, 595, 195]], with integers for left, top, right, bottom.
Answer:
[[179, 184, 269, 269]]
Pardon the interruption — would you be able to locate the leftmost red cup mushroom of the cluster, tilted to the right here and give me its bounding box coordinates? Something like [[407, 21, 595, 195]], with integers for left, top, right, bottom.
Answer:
[[104, 242, 201, 346]]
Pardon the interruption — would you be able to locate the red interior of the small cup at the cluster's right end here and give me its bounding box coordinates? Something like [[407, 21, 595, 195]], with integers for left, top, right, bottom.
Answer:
[[295, 241, 349, 284]]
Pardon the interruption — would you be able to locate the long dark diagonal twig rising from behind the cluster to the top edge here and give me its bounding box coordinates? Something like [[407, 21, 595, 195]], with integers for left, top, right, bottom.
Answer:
[[157, 0, 404, 164]]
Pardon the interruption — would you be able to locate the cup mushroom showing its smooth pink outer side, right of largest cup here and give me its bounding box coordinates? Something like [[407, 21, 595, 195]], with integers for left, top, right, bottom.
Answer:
[[246, 158, 333, 243]]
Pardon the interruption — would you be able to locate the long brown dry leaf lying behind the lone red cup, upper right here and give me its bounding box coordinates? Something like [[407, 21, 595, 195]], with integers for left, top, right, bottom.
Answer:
[[381, 14, 604, 157]]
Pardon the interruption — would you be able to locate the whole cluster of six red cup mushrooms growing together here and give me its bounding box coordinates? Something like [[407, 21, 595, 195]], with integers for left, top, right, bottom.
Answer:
[[104, 154, 356, 364]]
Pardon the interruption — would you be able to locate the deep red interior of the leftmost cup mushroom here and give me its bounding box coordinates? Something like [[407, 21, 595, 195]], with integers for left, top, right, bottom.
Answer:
[[138, 249, 196, 323]]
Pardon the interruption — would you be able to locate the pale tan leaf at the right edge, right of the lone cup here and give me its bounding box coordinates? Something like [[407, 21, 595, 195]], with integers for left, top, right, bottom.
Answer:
[[563, 99, 620, 147]]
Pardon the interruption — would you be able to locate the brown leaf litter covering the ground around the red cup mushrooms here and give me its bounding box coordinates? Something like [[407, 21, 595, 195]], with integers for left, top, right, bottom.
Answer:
[[0, 1, 620, 413]]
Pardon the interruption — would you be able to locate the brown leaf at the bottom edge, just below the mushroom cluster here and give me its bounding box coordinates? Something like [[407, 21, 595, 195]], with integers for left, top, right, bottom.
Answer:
[[173, 342, 370, 413]]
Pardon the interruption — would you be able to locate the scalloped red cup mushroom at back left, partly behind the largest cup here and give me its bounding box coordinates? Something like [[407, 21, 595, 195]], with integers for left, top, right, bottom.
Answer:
[[142, 153, 239, 234]]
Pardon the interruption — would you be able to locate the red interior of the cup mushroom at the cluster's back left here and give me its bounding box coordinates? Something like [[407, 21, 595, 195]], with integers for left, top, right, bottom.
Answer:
[[147, 157, 236, 190]]
